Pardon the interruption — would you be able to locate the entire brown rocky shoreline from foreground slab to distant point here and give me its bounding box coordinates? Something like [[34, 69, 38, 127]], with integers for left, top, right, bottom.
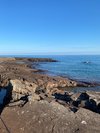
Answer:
[[0, 58, 100, 133]]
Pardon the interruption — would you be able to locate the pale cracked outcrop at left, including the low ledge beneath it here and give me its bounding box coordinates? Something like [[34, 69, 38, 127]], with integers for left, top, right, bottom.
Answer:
[[7, 79, 40, 106]]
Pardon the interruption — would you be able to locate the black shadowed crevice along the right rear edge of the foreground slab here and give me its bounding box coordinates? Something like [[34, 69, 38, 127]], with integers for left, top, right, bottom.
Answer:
[[53, 92, 100, 113]]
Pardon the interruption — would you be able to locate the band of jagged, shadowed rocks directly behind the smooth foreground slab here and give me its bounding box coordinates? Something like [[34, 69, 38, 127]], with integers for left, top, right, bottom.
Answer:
[[4, 80, 100, 113]]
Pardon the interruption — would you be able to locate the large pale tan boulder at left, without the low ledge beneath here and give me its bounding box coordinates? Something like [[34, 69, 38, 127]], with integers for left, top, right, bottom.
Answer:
[[7, 79, 39, 102]]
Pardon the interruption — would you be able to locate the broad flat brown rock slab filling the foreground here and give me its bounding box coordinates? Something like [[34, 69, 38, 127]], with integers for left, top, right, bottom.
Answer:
[[0, 100, 100, 133]]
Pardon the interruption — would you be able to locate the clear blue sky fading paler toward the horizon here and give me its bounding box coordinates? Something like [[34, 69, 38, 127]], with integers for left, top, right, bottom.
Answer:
[[0, 0, 100, 54]]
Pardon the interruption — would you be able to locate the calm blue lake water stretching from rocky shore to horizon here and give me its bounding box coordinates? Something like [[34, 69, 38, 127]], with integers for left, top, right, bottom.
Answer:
[[0, 55, 100, 91]]
